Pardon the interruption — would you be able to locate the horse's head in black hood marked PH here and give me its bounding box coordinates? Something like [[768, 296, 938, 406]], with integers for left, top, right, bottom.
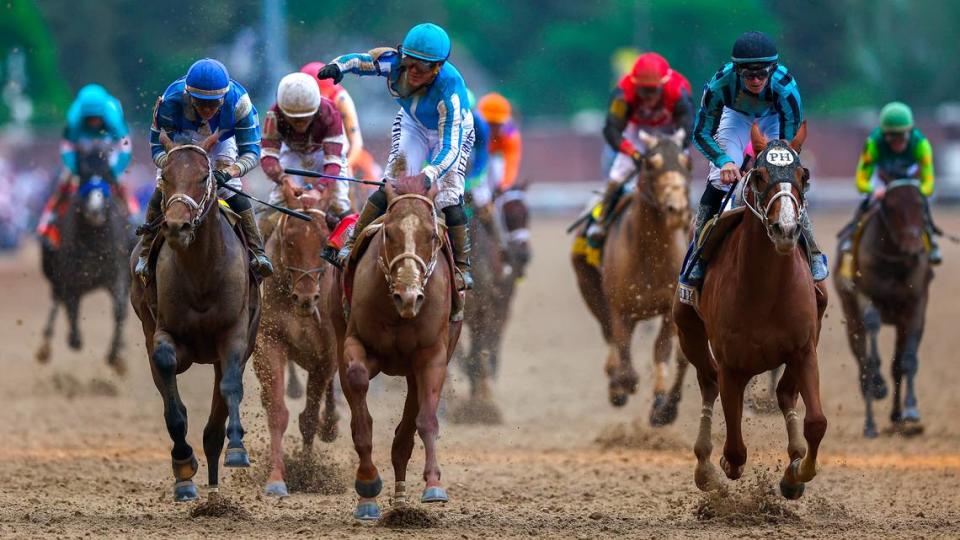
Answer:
[[744, 122, 810, 254]]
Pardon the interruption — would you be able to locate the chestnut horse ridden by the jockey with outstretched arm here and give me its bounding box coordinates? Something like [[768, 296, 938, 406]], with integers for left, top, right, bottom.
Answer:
[[328, 176, 461, 520]]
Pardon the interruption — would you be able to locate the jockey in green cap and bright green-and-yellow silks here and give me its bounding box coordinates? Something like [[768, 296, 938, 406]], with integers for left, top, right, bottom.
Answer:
[[840, 101, 943, 264]]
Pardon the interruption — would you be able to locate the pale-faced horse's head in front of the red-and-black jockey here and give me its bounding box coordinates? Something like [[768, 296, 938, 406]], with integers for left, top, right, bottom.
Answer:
[[637, 129, 691, 228]]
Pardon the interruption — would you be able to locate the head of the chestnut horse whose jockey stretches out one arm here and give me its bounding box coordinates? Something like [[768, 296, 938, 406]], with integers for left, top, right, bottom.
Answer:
[[379, 182, 442, 319]]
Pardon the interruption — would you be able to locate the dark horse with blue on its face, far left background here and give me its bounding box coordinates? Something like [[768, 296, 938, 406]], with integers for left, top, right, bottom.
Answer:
[[37, 141, 134, 375]]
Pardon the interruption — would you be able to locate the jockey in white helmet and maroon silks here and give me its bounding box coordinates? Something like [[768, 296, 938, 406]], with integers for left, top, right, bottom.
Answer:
[[260, 73, 350, 238]]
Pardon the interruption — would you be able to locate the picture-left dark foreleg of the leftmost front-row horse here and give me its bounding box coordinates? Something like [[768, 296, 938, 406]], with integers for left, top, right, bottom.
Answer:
[[150, 331, 199, 502]]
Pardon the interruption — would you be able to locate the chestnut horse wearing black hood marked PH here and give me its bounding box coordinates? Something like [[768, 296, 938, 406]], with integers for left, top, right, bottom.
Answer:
[[674, 121, 827, 499]]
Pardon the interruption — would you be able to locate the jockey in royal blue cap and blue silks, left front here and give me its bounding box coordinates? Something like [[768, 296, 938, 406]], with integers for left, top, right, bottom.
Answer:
[[135, 58, 273, 278]]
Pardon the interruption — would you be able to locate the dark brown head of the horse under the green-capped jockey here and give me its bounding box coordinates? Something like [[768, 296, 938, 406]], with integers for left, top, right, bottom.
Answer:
[[880, 178, 926, 255]]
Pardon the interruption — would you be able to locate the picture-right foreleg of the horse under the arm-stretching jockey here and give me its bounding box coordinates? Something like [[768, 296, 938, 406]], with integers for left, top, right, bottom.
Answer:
[[414, 347, 447, 502]]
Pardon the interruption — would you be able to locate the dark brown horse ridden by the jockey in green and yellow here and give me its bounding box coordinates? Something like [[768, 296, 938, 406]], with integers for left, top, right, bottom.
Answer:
[[834, 179, 933, 437]]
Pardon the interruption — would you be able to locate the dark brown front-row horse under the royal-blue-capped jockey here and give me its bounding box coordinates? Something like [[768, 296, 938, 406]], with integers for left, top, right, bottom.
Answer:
[[130, 133, 260, 501]]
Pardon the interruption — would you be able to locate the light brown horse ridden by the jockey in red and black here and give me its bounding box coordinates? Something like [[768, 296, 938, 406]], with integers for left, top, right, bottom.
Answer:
[[573, 132, 690, 425]]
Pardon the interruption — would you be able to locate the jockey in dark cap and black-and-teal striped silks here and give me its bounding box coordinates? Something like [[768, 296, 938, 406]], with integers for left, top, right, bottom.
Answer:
[[684, 32, 829, 286]]
